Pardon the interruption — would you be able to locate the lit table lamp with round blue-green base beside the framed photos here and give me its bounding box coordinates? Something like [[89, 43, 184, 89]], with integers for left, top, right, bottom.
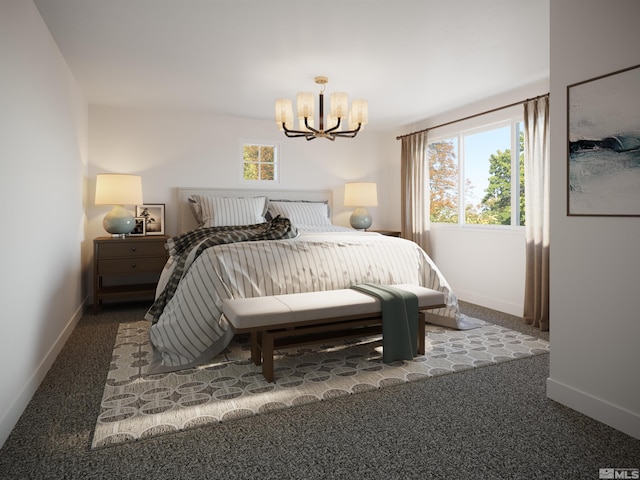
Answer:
[[95, 173, 142, 238]]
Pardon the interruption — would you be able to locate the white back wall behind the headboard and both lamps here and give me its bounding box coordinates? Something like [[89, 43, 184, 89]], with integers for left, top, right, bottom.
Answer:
[[88, 105, 400, 237]]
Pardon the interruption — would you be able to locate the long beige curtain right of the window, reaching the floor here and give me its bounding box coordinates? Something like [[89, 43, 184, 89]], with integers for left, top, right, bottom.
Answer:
[[523, 96, 550, 330]]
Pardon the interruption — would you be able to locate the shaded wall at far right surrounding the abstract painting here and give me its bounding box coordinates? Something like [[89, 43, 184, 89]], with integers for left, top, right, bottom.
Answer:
[[547, 0, 640, 438]]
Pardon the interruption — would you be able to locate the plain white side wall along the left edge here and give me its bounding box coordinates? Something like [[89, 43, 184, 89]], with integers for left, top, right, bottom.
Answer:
[[0, 0, 87, 445]]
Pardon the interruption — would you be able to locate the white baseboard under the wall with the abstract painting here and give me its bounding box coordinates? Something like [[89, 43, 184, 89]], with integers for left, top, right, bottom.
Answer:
[[547, 378, 640, 440]]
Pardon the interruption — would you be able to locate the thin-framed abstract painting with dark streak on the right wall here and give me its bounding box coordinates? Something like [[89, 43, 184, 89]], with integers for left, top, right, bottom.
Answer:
[[567, 65, 640, 217]]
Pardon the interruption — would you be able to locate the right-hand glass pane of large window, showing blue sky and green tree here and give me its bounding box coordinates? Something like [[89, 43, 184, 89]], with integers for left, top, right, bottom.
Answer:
[[463, 126, 511, 225]]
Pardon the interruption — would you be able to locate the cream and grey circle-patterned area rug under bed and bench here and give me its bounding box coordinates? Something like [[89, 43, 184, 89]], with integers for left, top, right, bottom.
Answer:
[[92, 321, 549, 448]]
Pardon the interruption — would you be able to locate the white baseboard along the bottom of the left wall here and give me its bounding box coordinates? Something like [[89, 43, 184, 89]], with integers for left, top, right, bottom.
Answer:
[[0, 299, 87, 448]]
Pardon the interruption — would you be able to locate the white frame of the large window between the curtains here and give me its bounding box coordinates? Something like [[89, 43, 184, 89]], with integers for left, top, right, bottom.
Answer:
[[427, 107, 525, 230]]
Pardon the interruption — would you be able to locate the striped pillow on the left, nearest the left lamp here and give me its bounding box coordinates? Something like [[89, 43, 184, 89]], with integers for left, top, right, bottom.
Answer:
[[189, 195, 267, 227]]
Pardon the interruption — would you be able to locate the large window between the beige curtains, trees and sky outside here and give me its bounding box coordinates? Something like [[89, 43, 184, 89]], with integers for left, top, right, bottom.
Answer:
[[427, 117, 525, 226]]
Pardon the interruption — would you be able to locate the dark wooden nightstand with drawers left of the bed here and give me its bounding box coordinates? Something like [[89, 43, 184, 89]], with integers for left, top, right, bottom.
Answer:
[[93, 235, 169, 314]]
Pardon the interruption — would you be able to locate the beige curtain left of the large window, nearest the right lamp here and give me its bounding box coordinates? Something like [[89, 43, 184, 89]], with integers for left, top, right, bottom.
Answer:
[[400, 131, 431, 255]]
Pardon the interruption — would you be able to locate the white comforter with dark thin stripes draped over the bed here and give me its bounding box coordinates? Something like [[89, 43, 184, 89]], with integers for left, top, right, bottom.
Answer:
[[150, 231, 473, 372]]
